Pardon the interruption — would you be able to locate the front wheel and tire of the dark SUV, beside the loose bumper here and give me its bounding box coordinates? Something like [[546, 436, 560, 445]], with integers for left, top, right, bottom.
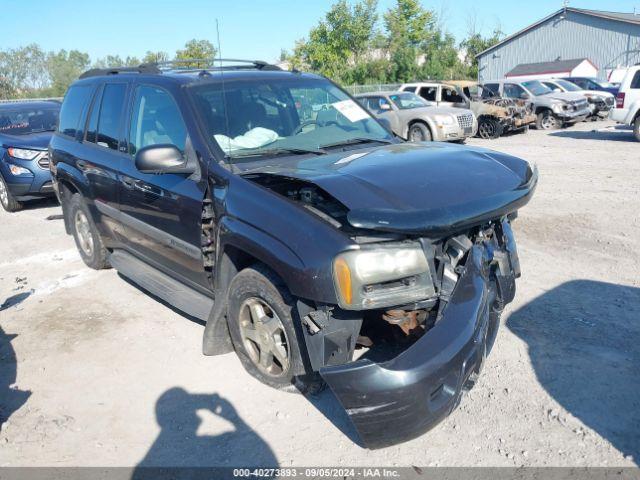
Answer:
[[227, 265, 325, 394]]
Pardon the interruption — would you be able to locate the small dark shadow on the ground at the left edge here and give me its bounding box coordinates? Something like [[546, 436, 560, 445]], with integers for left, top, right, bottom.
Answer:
[[0, 327, 31, 431]]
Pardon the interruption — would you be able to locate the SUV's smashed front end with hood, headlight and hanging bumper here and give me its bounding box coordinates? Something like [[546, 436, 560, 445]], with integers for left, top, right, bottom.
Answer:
[[242, 143, 538, 448]]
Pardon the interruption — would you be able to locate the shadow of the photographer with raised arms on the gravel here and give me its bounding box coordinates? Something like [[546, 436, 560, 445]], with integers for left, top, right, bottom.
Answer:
[[132, 387, 278, 479]]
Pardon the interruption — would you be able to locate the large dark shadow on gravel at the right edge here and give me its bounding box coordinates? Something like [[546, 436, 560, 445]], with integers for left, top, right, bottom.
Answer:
[[506, 280, 640, 464]]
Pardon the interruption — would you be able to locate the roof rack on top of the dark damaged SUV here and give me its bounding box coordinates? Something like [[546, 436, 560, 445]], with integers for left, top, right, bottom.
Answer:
[[80, 58, 282, 78]]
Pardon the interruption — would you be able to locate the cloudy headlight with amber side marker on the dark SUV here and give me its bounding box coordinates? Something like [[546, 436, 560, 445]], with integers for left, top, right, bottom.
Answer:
[[333, 243, 435, 310]]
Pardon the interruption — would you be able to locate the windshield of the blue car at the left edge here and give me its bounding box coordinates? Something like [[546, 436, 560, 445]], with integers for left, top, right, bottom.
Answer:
[[0, 105, 60, 135]]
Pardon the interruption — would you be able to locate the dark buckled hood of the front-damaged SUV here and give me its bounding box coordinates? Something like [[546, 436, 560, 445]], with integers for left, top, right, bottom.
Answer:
[[245, 142, 537, 235]]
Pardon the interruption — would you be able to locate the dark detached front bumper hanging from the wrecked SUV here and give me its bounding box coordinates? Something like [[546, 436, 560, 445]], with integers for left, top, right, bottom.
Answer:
[[320, 238, 519, 448]]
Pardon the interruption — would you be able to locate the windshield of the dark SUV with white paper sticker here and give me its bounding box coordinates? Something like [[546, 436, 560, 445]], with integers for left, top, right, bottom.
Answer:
[[192, 75, 392, 159]]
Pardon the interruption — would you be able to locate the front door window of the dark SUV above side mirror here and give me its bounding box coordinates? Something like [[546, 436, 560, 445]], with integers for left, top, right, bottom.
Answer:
[[129, 85, 187, 155]]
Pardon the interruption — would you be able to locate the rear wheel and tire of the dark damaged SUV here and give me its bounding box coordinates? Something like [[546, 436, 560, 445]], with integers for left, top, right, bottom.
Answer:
[[65, 193, 109, 270]]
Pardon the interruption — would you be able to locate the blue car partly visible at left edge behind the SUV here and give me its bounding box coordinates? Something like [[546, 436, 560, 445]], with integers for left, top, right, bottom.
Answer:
[[0, 101, 60, 212]]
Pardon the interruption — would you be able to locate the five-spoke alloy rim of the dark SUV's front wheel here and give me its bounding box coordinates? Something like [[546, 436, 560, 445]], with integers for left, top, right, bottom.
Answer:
[[239, 297, 290, 377]]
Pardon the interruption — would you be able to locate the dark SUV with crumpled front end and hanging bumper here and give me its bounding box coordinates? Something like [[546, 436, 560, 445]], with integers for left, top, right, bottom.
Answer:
[[49, 61, 537, 448]]
